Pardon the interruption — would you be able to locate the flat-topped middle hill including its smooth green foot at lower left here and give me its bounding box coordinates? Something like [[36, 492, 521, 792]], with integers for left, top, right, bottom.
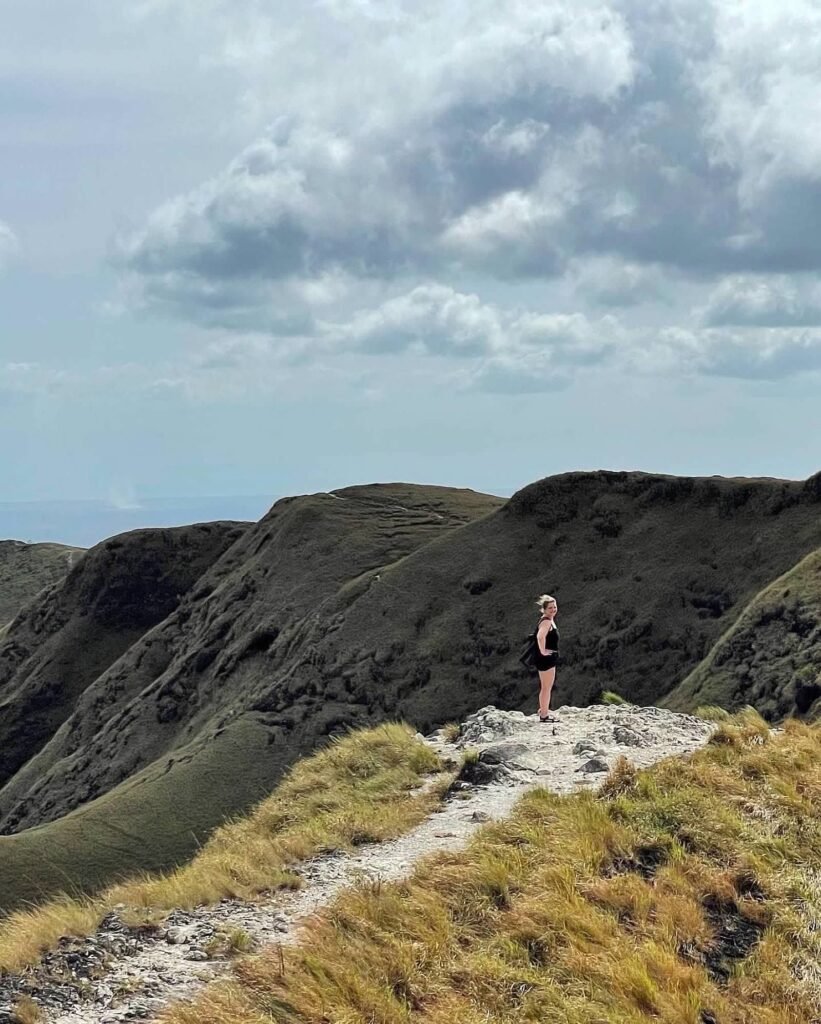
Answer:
[[0, 484, 504, 910]]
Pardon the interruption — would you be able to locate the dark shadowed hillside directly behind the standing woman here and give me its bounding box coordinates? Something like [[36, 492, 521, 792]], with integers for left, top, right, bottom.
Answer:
[[298, 472, 821, 728]]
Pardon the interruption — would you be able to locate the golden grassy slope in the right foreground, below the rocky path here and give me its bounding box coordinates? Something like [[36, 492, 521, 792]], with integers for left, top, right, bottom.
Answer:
[[161, 715, 821, 1024]]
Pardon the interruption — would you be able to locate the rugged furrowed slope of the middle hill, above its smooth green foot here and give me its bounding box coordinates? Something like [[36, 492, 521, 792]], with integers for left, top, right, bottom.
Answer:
[[0, 484, 503, 842]]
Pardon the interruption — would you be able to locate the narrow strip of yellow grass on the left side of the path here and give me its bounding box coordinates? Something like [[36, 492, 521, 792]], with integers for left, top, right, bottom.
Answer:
[[0, 724, 452, 970]]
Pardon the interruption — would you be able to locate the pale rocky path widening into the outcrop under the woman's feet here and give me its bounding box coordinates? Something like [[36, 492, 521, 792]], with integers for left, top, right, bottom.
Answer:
[[0, 705, 712, 1024]]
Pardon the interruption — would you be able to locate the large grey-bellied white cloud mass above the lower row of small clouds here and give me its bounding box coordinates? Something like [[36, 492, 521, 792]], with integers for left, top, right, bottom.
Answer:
[[119, 0, 821, 314]]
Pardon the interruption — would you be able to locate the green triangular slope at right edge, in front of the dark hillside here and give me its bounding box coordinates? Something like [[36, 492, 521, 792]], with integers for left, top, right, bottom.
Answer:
[[662, 549, 821, 718]]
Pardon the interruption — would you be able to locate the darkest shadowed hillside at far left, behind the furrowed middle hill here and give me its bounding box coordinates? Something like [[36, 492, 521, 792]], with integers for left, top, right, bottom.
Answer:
[[0, 523, 247, 799]]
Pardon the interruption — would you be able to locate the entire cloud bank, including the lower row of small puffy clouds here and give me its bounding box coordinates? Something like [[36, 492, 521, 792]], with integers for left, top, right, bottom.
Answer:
[[102, 0, 821, 389]]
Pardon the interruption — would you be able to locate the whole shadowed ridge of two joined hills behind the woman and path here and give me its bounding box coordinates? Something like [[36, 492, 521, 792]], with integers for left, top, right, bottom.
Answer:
[[0, 472, 821, 905]]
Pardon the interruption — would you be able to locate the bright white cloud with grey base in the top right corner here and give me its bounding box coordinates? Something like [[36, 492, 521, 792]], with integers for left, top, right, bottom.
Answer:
[[700, 0, 821, 272]]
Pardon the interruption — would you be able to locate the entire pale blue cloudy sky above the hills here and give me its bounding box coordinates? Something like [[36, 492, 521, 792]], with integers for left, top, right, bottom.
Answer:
[[0, 0, 821, 512]]
